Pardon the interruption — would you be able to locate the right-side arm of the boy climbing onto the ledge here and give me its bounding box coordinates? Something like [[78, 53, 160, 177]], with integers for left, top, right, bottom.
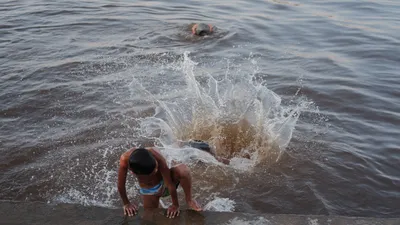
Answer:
[[150, 149, 179, 207]]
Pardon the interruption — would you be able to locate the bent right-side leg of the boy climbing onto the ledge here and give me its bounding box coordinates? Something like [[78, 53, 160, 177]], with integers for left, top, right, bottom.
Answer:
[[171, 164, 202, 211]]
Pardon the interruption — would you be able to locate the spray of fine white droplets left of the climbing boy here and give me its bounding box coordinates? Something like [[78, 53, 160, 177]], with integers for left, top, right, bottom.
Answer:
[[48, 147, 134, 208]]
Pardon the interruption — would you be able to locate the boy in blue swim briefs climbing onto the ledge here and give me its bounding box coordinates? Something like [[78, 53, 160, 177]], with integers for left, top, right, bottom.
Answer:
[[118, 148, 202, 218]]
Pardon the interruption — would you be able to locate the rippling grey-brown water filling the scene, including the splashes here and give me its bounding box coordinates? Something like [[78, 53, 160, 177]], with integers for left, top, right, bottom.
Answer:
[[0, 0, 400, 218]]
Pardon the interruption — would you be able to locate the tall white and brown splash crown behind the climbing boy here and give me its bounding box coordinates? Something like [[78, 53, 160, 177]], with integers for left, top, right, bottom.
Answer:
[[140, 52, 308, 164]]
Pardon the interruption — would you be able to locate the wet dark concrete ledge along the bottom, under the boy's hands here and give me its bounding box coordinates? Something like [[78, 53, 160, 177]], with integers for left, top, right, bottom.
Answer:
[[0, 201, 400, 225]]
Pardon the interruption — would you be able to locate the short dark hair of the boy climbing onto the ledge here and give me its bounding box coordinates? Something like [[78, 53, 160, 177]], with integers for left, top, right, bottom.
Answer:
[[129, 148, 156, 175]]
